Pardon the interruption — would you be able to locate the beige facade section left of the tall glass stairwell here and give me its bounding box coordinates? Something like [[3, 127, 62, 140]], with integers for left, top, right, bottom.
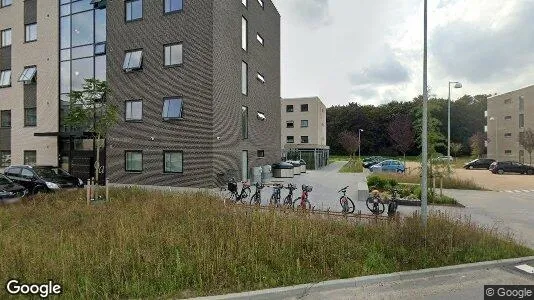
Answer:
[[0, 0, 59, 166]]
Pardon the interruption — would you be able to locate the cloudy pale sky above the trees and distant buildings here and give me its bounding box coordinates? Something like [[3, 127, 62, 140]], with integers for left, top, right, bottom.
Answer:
[[272, 0, 534, 107]]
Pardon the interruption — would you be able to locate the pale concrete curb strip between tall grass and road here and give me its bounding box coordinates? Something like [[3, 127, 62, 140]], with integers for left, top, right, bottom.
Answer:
[[193, 256, 534, 300]]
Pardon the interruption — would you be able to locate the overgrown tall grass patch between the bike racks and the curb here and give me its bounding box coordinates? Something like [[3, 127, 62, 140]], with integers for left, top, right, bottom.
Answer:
[[0, 189, 533, 299]]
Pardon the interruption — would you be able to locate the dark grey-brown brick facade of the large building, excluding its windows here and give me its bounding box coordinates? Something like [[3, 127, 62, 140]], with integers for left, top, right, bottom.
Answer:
[[106, 0, 280, 187]]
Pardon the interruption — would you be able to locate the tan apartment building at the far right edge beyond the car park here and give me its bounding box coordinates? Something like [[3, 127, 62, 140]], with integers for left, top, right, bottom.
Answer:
[[485, 85, 534, 163]]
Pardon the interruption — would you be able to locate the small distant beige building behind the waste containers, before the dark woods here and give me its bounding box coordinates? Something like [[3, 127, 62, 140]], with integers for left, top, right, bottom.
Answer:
[[281, 97, 330, 169]]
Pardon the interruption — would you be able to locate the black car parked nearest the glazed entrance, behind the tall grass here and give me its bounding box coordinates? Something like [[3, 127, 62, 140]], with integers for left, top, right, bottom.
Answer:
[[4, 165, 83, 194]]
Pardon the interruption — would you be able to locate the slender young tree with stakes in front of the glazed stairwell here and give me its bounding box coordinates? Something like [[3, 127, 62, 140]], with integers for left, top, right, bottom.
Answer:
[[65, 79, 119, 183]]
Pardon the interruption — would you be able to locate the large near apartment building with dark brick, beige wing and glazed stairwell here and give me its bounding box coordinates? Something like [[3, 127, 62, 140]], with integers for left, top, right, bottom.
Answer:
[[0, 0, 280, 187]]
